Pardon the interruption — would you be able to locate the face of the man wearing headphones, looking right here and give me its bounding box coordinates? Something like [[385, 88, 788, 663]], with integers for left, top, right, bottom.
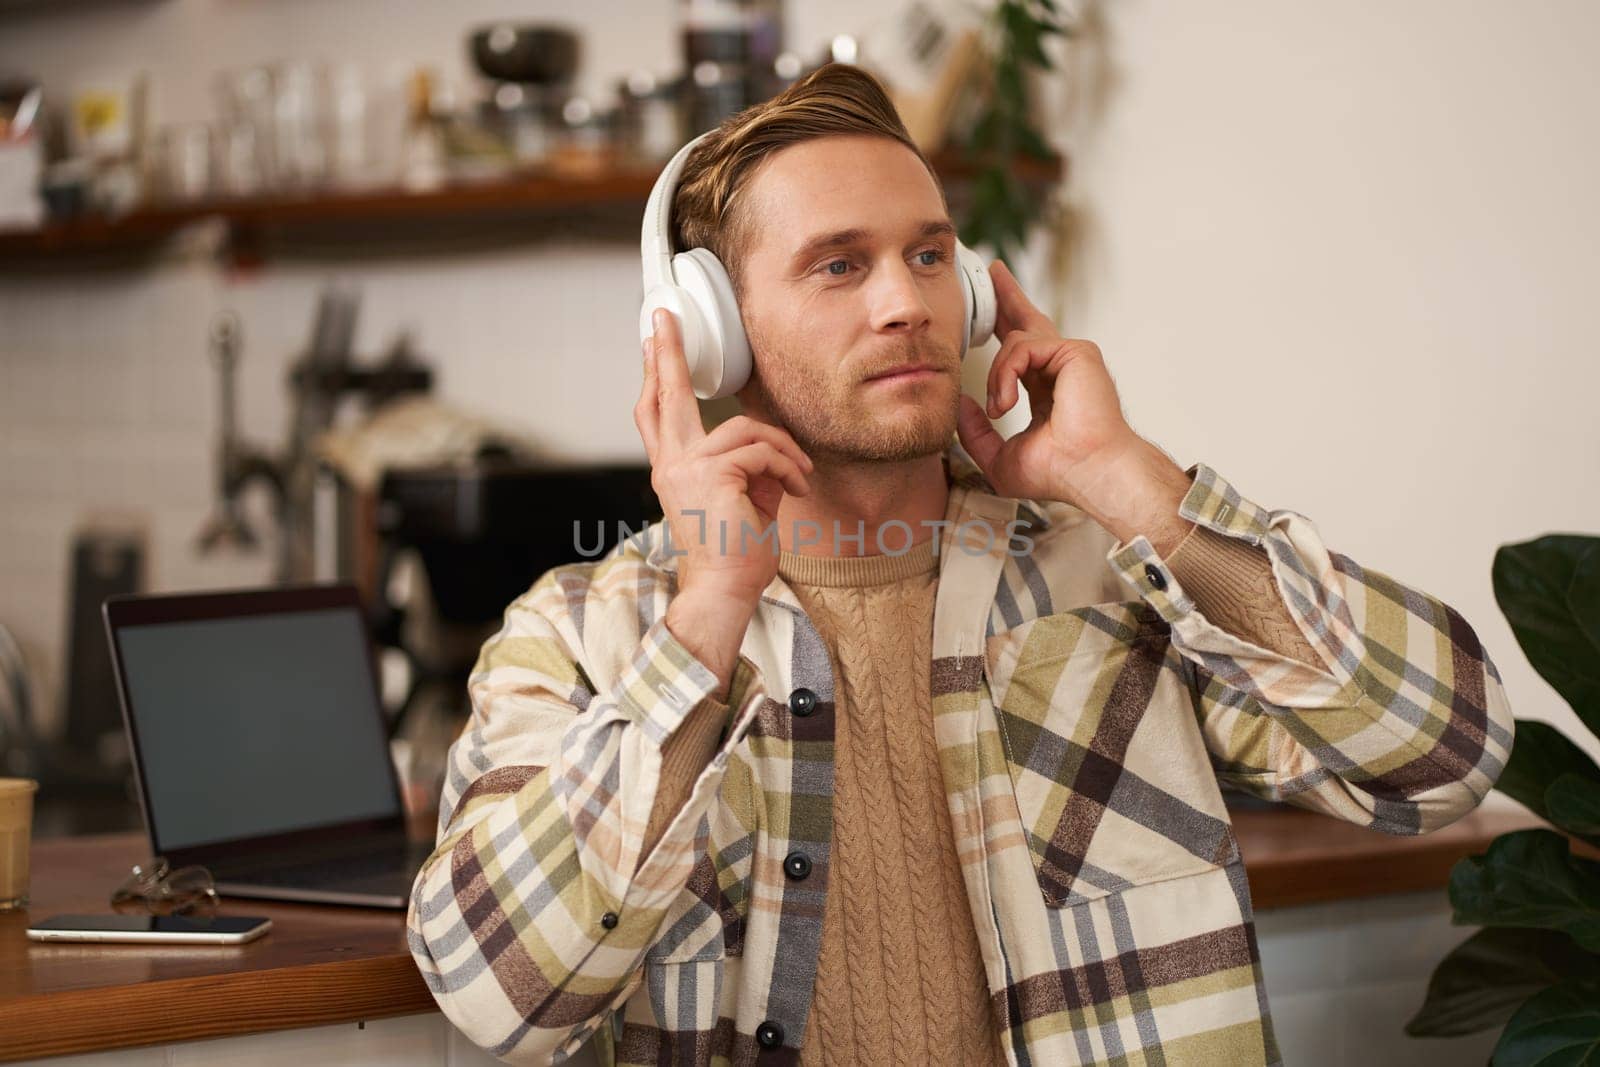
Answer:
[[739, 134, 966, 461]]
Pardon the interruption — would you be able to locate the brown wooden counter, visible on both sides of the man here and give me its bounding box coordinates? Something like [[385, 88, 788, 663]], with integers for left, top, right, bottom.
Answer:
[[0, 809, 1539, 1061]]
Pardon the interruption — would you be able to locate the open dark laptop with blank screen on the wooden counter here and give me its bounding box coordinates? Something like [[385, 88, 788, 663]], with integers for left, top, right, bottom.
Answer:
[[102, 584, 432, 909]]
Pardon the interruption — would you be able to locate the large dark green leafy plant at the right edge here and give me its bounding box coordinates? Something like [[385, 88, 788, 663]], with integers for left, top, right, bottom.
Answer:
[[1406, 534, 1600, 1067]]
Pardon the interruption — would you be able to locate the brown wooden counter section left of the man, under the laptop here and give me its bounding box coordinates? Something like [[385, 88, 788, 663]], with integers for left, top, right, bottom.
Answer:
[[0, 833, 437, 1062]]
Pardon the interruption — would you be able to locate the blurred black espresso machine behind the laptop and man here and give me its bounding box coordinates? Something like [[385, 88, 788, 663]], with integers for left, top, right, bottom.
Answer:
[[200, 290, 661, 808]]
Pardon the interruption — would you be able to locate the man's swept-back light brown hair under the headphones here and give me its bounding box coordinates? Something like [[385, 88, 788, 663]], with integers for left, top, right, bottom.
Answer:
[[670, 62, 944, 298]]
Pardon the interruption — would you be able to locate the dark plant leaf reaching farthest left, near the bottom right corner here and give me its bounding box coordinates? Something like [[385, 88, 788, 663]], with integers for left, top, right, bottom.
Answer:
[[1405, 926, 1600, 1037]]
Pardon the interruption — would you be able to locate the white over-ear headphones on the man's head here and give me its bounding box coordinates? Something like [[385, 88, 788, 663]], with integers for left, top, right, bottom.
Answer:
[[638, 133, 995, 400]]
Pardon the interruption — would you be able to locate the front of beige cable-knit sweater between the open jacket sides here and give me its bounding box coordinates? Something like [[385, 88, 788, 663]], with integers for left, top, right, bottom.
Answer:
[[779, 539, 1006, 1067]]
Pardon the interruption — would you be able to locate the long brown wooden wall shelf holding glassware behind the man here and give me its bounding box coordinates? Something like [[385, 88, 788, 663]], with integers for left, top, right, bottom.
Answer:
[[0, 154, 1066, 269]]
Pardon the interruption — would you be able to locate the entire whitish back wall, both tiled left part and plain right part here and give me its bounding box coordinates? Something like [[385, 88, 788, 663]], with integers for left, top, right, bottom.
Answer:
[[0, 0, 1600, 767]]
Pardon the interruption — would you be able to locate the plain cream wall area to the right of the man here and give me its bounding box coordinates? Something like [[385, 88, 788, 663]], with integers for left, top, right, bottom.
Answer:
[[1053, 0, 1600, 752]]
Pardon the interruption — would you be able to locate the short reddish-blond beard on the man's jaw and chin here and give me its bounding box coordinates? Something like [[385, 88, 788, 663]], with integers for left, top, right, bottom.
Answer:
[[749, 326, 962, 462]]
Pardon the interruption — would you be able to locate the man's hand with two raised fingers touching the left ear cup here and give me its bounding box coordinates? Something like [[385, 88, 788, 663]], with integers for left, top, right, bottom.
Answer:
[[634, 303, 811, 691]]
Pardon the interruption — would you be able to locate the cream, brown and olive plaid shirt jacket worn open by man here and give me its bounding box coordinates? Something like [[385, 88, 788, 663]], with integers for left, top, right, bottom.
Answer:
[[406, 443, 1512, 1067]]
